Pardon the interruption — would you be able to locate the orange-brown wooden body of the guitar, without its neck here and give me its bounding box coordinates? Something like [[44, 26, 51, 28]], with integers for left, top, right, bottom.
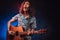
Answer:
[[7, 26, 24, 40]]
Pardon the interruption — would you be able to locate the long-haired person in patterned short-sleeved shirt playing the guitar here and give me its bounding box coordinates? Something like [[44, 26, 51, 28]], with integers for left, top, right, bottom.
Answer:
[[8, 0, 36, 40]]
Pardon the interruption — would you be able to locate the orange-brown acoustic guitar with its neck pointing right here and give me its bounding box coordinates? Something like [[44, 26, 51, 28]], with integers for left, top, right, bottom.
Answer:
[[6, 26, 46, 40]]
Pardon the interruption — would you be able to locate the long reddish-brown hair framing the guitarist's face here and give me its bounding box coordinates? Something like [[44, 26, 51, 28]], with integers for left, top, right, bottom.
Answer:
[[19, 0, 35, 17]]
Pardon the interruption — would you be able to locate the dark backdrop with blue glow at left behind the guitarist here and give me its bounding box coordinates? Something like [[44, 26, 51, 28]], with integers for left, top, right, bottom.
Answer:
[[0, 0, 59, 40]]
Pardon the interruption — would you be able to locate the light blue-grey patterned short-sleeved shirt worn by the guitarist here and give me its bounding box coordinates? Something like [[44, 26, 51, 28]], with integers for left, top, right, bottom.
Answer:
[[12, 13, 36, 30]]
